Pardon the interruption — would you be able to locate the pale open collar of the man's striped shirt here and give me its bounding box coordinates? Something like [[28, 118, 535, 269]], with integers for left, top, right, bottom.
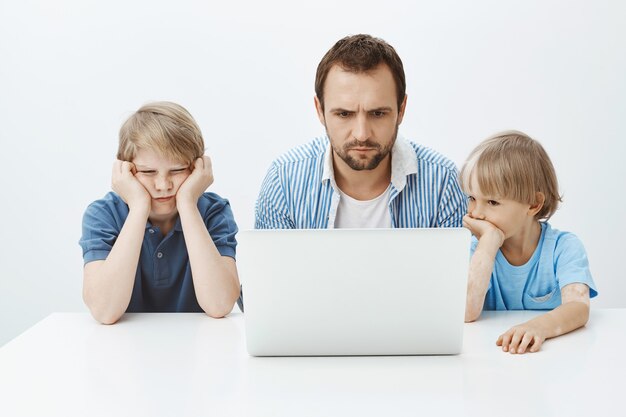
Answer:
[[322, 135, 417, 192]]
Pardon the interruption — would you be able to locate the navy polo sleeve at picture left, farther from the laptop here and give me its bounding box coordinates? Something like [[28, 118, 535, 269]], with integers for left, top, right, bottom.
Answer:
[[78, 199, 128, 264]]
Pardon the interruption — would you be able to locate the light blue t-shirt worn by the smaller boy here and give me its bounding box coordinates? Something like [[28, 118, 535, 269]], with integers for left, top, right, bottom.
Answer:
[[471, 222, 598, 310]]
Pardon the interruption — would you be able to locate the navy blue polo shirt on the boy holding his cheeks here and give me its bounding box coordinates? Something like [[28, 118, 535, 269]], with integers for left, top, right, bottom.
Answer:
[[79, 192, 237, 312]]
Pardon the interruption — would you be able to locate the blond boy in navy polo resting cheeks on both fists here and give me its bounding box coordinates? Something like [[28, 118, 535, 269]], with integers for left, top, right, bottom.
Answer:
[[80, 102, 240, 324]]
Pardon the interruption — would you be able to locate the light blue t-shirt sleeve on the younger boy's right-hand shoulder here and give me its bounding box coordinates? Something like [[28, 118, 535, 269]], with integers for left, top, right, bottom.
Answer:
[[554, 233, 598, 297]]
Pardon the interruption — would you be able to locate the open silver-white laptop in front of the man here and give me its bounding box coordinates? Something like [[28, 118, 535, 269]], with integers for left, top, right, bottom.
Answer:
[[237, 228, 471, 356]]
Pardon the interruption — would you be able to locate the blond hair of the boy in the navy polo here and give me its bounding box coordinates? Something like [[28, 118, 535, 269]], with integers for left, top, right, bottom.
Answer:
[[117, 101, 204, 165]]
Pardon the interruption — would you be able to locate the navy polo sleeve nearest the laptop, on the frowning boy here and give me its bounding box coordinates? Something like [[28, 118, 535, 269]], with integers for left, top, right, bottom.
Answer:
[[203, 194, 239, 258]]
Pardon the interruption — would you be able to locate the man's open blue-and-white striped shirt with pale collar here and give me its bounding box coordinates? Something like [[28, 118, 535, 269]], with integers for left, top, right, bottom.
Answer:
[[255, 136, 467, 229]]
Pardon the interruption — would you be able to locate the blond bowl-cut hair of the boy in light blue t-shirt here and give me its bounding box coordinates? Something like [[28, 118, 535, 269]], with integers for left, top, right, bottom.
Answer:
[[459, 130, 562, 220]]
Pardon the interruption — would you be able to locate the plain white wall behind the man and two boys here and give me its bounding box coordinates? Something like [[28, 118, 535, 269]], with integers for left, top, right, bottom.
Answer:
[[0, 0, 626, 345]]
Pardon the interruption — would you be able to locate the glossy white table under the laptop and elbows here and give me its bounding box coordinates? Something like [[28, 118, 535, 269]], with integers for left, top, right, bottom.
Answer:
[[0, 309, 626, 417]]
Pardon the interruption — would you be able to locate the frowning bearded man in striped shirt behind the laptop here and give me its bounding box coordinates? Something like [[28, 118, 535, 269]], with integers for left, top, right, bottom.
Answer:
[[255, 35, 467, 229]]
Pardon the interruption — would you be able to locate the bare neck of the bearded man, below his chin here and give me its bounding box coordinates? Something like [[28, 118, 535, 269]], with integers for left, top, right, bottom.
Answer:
[[333, 151, 391, 201]]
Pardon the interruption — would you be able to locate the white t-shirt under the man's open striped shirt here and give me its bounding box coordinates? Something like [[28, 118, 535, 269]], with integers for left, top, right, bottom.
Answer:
[[335, 185, 391, 229]]
